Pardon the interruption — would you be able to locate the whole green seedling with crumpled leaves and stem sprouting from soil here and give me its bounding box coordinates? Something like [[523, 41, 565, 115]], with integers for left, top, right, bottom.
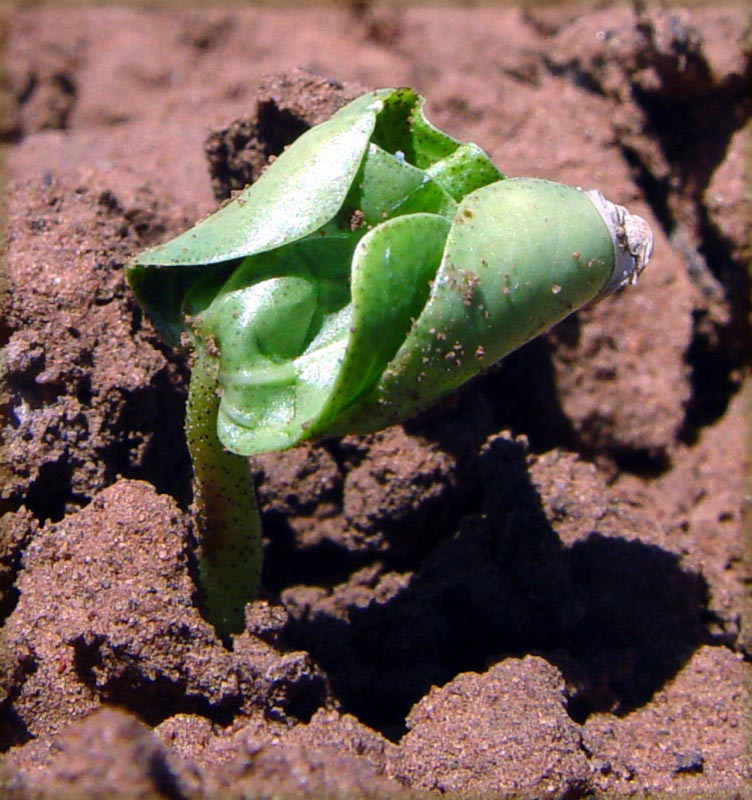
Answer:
[[127, 89, 652, 637]]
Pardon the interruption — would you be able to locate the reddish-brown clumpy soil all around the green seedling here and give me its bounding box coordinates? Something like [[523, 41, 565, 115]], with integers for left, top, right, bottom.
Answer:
[[0, 2, 752, 800]]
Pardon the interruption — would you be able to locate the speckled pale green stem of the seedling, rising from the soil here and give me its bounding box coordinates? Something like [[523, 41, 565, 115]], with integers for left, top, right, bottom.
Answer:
[[185, 353, 262, 639]]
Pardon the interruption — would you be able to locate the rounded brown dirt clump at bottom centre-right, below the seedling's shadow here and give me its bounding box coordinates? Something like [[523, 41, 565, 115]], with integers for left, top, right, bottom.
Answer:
[[392, 656, 588, 796]]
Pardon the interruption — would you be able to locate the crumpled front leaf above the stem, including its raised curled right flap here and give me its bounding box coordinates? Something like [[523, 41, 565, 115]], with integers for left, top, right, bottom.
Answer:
[[207, 214, 449, 455]]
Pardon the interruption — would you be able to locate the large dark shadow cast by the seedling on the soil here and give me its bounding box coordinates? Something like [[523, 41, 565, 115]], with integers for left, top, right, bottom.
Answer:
[[282, 437, 709, 739]]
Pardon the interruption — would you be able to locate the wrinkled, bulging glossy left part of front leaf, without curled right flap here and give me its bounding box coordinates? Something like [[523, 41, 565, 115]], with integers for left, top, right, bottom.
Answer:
[[193, 233, 359, 453]]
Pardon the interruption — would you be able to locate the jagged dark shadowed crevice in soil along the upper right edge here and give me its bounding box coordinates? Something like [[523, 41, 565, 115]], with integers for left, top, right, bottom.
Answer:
[[623, 48, 752, 443]]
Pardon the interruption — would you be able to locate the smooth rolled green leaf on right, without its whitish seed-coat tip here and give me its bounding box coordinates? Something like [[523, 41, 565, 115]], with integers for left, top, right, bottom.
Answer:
[[336, 178, 614, 432]]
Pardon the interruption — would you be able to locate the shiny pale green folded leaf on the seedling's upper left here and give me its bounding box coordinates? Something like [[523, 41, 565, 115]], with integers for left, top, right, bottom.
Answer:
[[127, 89, 393, 345]]
